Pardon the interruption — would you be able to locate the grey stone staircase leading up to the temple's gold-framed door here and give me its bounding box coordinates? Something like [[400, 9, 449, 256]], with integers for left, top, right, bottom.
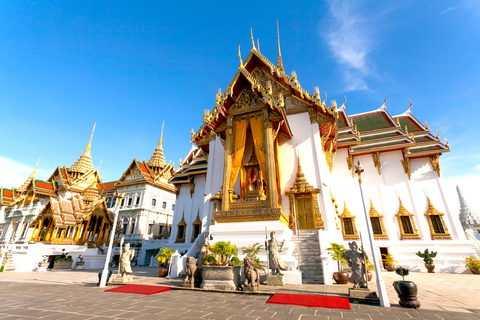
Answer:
[[292, 230, 324, 284]]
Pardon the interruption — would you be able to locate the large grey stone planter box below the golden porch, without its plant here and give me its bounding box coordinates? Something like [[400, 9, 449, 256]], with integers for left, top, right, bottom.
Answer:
[[202, 265, 241, 291]]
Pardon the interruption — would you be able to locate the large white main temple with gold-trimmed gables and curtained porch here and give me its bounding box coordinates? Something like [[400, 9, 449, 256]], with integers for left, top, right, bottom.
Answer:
[[166, 27, 473, 284]]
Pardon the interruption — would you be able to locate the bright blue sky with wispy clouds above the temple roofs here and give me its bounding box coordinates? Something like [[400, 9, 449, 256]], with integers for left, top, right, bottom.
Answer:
[[0, 1, 480, 210]]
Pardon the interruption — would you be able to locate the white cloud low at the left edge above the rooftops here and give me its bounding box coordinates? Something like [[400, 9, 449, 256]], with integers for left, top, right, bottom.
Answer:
[[0, 156, 48, 188]]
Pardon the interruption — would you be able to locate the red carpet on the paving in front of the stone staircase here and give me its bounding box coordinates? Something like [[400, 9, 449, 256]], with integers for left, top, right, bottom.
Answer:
[[267, 293, 351, 310]]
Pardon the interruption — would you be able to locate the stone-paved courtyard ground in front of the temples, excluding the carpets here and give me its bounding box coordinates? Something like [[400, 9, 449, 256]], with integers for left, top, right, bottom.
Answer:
[[0, 268, 480, 320]]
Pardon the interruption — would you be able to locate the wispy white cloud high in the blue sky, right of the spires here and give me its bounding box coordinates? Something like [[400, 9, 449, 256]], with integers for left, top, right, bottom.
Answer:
[[325, 1, 372, 91]]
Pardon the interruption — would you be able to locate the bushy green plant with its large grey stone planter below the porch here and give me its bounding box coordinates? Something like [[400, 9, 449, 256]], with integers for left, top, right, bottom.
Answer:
[[202, 241, 241, 290]]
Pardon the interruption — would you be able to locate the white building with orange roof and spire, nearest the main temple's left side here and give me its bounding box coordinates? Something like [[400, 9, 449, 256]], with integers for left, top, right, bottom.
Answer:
[[106, 122, 175, 265]]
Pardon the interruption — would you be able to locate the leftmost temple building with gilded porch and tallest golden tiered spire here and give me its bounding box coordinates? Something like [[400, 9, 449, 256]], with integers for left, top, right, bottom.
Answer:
[[0, 127, 113, 271]]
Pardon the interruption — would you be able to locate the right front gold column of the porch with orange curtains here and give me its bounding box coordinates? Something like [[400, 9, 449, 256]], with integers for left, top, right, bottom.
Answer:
[[262, 112, 278, 208]]
